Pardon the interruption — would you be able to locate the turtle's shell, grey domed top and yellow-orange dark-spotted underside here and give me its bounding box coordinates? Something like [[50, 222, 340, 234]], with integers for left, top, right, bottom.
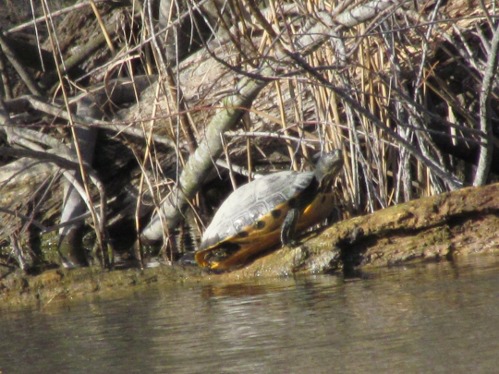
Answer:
[[195, 171, 332, 270]]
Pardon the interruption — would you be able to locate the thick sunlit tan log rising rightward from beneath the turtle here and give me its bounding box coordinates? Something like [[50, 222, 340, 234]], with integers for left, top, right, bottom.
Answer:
[[223, 183, 499, 279]]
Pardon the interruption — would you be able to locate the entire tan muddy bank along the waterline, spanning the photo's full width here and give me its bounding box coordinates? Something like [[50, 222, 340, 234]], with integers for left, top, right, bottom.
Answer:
[[0, 184, 499, 307]]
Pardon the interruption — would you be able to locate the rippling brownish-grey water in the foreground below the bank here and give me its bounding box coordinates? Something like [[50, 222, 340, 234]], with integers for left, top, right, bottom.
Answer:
[[0, 256, 499, 374]]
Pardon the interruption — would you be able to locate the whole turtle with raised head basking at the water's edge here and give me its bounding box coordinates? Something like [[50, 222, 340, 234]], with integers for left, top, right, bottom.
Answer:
[[194, 149, 343, 271]]
